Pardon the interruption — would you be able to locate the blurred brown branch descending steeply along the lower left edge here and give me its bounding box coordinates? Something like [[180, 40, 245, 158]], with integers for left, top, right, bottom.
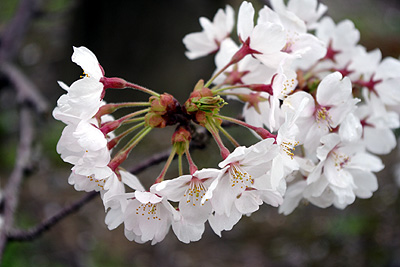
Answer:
[[0, 105, 34, 260]]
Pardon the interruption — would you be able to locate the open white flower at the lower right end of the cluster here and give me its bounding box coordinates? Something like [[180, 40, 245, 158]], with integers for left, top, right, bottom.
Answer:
[[304, 133, 383, 209]]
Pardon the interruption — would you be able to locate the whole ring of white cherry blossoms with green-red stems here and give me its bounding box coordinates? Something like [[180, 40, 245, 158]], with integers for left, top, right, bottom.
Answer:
[[53, 0, 400, 244]]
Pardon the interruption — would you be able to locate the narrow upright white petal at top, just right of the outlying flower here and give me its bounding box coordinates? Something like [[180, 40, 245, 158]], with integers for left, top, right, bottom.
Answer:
[[237, 1, 254, 42]]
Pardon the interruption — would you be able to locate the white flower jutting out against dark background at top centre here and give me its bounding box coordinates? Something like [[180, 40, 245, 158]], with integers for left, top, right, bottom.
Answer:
[[183, 5, 234, 59]]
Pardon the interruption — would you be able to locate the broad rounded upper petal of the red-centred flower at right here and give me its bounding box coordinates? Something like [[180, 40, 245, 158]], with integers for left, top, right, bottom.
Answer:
[[317, 72, 352, 106]]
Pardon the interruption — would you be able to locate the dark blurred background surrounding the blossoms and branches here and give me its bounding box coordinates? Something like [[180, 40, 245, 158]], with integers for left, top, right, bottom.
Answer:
[[0, 0, 400, 266]]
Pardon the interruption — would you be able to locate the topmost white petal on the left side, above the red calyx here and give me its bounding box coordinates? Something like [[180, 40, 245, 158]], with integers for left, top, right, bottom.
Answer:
[[71, 46, 103, 81]]
